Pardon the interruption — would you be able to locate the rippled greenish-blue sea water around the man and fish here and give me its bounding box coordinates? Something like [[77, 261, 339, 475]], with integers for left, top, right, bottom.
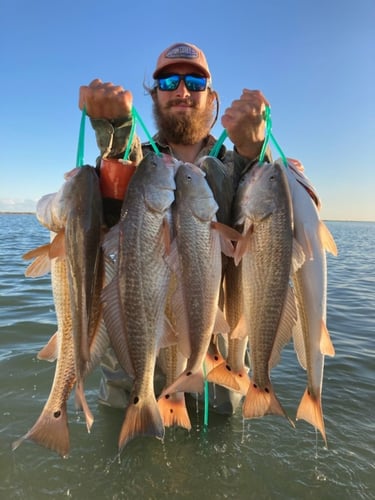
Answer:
[[0, 214, 375, 500]]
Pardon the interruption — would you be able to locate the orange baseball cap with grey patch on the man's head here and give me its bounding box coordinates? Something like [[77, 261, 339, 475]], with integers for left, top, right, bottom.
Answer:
[[152, 42, 211, 79]]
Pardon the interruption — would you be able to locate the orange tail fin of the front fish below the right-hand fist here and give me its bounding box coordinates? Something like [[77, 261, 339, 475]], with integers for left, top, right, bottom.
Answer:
[[242, 380, 295, 427]]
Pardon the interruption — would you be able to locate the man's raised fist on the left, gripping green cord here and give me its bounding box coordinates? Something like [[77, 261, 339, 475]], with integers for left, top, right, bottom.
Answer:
[[79, 79, 133, 120]]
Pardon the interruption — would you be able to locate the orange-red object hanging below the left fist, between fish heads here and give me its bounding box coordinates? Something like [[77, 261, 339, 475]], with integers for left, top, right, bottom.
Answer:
[[100, 158, 136, 200]]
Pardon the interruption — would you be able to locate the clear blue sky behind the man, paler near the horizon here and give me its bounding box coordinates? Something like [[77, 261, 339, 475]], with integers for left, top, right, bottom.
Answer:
[[0, 0, 375, 221]]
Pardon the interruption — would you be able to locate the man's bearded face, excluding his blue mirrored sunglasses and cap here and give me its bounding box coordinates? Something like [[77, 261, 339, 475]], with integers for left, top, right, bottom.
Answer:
[[153, 64, 214, 145]]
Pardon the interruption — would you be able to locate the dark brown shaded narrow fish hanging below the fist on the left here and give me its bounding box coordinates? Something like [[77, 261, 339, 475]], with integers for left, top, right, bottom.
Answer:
[[64, 165, 103, 431]]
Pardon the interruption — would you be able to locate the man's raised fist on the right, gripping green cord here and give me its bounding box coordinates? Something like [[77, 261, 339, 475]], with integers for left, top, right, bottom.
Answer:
[[221, 89, 269, 159]]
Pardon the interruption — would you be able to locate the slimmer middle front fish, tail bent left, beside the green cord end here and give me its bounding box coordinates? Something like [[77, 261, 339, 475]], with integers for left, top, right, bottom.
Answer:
[[160, 163, 226, 398]]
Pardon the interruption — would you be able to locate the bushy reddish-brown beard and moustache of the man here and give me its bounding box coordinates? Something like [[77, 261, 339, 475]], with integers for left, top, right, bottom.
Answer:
[[153, 99, 214, 146]]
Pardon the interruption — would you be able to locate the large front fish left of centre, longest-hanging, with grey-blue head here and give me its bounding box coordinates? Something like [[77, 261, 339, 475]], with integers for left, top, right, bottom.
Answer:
[[102, 153, 176, 451]]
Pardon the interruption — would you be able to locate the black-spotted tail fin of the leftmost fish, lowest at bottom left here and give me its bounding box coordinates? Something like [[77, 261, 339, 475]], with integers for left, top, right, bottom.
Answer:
[[12, 404, 70, 458]]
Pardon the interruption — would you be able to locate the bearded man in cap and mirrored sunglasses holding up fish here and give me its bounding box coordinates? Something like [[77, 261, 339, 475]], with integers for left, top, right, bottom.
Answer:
[[79, 43, 270, 415]]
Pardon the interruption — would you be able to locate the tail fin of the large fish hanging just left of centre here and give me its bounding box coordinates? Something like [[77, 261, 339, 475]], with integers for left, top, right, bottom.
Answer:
[[119, 395, 164, 451]]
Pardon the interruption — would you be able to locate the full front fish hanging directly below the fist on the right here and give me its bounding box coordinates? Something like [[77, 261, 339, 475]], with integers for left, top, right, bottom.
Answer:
[[235, 163, 293, 418]]
